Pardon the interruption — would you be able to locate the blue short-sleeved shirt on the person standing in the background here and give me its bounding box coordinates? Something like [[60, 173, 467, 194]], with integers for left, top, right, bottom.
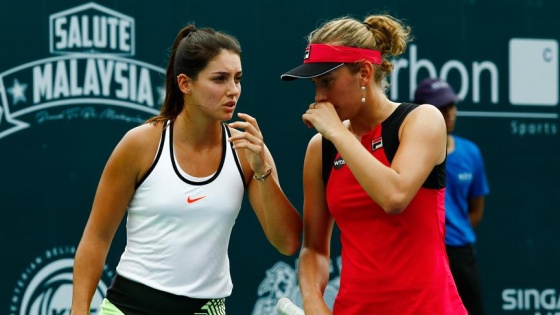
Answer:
[[445, 136, 490, 246]]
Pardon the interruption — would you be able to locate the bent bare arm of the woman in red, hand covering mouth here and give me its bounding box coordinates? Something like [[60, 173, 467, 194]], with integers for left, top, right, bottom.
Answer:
[[303, 103, 446, 214]]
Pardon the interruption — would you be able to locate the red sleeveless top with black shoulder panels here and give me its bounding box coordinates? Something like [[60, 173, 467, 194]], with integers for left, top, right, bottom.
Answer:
[[326, 104, 467, 315]]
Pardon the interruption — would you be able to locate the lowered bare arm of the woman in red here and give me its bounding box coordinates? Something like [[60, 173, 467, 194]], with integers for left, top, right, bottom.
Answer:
[[298, 134, 334, 315]]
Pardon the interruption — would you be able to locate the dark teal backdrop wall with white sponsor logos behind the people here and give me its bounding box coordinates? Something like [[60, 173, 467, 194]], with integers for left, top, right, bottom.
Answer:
[[0, 0, 560, 315]]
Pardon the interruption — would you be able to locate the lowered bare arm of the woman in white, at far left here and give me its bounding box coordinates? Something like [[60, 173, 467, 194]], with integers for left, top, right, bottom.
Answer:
[[72, 126, 159, 315]]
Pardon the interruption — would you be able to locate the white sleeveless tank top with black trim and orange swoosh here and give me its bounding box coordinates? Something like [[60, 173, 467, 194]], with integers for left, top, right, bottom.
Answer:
[[117, 123, 245, 298]]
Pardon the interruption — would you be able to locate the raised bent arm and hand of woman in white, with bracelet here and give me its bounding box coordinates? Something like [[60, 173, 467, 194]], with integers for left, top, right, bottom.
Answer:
[[230, 114, 302, 255]]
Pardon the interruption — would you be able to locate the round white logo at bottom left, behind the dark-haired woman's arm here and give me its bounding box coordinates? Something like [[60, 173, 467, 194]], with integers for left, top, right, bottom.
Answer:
[[9, 247, 112, 315]]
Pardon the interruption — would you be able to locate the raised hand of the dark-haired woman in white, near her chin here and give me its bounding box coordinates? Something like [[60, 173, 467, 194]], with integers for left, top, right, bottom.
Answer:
[[229, 113, 270, 176]]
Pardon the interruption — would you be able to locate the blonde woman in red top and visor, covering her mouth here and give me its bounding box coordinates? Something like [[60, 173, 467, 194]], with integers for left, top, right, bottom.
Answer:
[[282, 15, 467, 315]]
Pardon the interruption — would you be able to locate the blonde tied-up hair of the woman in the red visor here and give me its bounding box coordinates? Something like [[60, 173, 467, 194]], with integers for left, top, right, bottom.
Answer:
[[307, 14, 412, 90]]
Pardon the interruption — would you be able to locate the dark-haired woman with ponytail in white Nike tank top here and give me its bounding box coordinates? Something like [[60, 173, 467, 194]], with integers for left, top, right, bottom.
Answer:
[[72, 25, 302, 315]]
